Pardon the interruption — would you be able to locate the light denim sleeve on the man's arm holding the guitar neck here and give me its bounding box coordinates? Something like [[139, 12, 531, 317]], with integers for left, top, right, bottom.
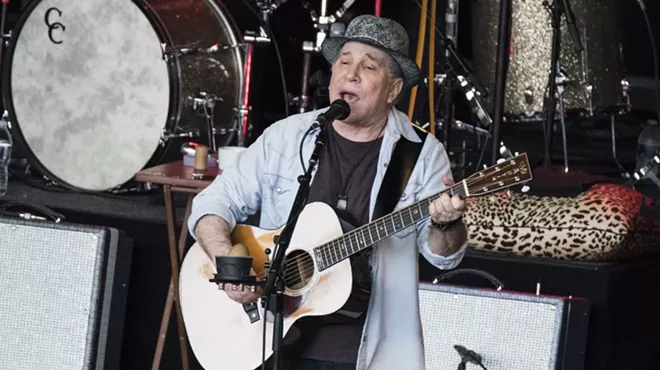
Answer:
[[417, 141, 468, 270]]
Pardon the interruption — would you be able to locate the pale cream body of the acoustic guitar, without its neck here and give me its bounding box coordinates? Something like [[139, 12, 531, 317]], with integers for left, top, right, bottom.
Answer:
[[179, 203, 353, 370]]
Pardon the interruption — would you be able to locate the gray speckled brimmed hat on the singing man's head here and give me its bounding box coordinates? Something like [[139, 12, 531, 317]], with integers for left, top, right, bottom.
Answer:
[[321, 14, 422, 90]]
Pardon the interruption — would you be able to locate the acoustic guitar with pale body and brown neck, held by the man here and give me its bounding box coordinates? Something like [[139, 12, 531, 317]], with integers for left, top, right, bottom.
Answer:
[[179, 154, 532, 370]]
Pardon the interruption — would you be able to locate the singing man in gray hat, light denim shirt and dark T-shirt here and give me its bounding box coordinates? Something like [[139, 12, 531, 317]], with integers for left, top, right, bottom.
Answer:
[[188, 15, 467, 370]]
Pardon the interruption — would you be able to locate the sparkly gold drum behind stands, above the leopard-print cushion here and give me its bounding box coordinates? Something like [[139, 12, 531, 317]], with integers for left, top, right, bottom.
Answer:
[[472, 0, 624, 121]]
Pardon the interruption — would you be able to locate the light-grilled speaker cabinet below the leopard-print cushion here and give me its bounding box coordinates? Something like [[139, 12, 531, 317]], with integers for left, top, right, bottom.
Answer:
[[419, 283, 589, 370]]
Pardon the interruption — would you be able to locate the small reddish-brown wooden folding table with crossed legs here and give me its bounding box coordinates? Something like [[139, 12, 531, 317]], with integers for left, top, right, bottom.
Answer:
[[135, 161, 220, 370]]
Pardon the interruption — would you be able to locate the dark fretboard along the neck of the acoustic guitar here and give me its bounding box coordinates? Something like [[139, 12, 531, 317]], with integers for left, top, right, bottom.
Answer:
[[314, 180, 469, 271]]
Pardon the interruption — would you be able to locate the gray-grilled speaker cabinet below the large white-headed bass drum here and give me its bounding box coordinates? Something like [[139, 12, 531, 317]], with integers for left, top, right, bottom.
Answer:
[[0, 217, 133, 370]]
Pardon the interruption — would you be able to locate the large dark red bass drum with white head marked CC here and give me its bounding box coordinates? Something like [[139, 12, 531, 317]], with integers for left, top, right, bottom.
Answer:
[[2, 0, 243, 191]]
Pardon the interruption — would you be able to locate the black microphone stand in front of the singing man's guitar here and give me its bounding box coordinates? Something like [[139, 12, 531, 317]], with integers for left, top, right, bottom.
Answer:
[[262, 120, 332, 370]]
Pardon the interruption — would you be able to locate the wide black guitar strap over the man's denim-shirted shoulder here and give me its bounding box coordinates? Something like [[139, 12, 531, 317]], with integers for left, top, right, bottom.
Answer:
[[372, 126, 428, 220]]
